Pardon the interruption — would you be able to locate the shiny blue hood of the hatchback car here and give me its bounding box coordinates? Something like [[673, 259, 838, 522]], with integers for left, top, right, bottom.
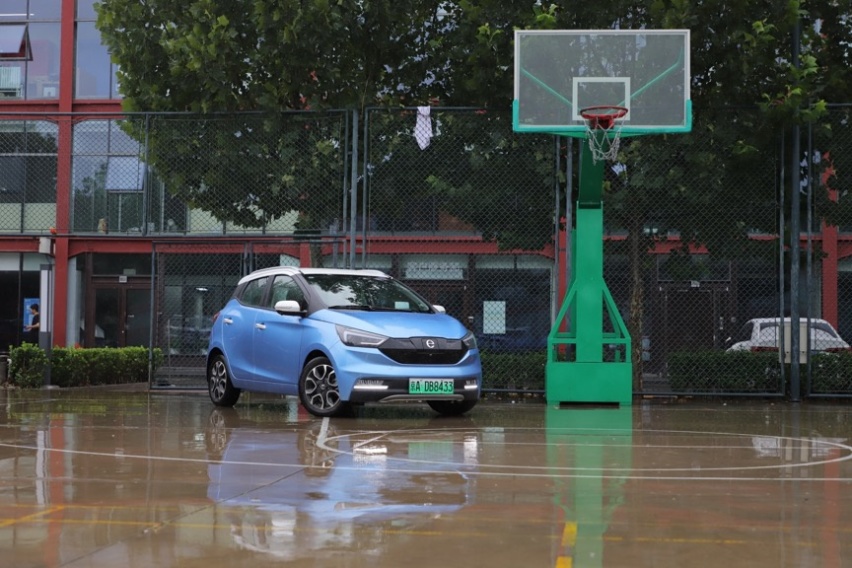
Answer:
[[309, 310, 468, 339]]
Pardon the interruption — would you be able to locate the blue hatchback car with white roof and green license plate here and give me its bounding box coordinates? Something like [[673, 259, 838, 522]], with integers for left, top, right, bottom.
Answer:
[[207, 267, 482, 416]]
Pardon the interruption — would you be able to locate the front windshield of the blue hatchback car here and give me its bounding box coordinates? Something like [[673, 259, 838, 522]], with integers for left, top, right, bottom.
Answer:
[[305, 274, 432, 312]]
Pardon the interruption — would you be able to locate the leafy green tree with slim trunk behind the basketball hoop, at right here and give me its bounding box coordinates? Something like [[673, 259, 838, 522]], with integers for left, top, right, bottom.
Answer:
[[607, 0, 850, 383]]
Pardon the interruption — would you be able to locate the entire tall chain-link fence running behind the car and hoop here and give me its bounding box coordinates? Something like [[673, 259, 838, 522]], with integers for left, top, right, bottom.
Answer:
[[6, 107, 852, 396]]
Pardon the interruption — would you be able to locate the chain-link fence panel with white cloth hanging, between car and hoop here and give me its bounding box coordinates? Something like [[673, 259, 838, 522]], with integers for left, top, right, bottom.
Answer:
[[361, 108, 564, 391]]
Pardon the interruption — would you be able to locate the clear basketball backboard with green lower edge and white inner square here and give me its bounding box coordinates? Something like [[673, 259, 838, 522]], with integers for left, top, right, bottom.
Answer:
[[513, 30, 692, 138]]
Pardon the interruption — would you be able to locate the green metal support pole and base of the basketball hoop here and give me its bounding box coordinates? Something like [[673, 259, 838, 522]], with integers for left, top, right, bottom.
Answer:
[[545, 141, 633, 405]]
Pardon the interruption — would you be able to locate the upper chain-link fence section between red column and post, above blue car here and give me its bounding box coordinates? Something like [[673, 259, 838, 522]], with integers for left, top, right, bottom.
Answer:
[[72, 113, 349, 236]]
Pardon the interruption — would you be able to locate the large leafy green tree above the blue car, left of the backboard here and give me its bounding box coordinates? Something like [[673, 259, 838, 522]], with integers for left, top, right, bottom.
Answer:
[[98, 0, 555, 236]]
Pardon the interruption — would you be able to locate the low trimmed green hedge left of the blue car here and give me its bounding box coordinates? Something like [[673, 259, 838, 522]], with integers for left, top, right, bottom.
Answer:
[[9, 343, 163, 388]]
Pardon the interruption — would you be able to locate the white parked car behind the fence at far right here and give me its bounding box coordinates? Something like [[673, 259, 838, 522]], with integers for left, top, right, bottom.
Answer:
[[727, 318, 852, 363]]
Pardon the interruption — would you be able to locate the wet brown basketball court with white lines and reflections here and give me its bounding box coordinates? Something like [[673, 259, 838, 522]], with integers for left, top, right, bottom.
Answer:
[[0, 390, 852, 568]]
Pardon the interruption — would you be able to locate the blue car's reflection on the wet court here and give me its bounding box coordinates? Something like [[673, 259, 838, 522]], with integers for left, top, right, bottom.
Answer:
[[207, 409, 478, 561]]
